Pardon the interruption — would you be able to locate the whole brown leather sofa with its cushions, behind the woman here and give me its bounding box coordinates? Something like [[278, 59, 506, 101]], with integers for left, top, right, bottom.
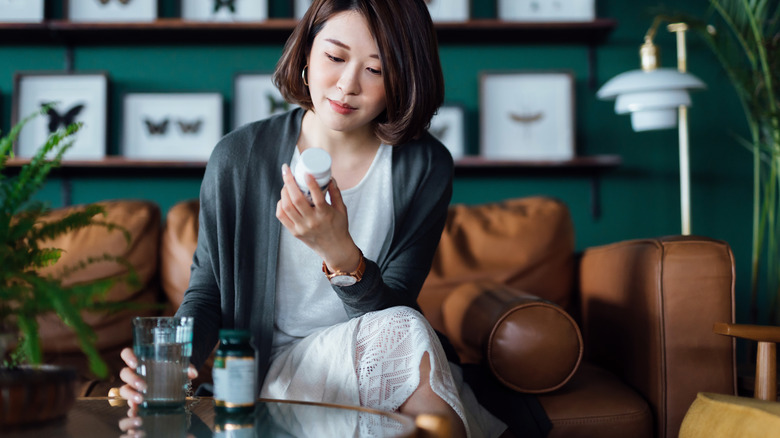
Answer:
[[36, 197, 736, 438]]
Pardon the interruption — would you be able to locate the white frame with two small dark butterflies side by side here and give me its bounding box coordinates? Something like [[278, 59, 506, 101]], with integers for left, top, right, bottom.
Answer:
[[122, 92, 224, 161]]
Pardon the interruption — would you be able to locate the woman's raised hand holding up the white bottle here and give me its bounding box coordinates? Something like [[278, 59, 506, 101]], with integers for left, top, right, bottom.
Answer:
[[276, 164, 360, 272]]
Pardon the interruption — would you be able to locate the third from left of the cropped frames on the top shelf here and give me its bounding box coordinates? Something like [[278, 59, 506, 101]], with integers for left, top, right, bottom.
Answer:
[[181, 0, 268, 22]]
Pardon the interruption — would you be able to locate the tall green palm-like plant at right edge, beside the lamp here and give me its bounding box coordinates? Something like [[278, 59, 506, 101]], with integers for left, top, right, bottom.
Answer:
[[695, 0, 780, 324]]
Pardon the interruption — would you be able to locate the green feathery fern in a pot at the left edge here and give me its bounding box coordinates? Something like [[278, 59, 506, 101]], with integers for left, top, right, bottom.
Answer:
[[0, 107, 137, 377]]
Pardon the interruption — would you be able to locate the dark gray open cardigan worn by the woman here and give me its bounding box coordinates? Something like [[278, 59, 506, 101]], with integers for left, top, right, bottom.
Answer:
[[176, 109, 453, 385]]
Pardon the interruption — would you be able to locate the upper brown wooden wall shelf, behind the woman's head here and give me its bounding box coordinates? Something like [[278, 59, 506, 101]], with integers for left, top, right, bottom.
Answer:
[[0, 18, 617, 46]]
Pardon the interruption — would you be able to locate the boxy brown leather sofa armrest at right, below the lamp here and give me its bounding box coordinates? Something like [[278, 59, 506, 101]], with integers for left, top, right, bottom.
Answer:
[[579, 236, 736, 436]]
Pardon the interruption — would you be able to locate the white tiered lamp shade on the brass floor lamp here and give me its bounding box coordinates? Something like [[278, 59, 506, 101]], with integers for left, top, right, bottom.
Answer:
[[596, 68, 705, 131]]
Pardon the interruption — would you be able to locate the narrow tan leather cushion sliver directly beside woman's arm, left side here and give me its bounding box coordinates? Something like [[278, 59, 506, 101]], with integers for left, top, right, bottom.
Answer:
[[160, 199, 200, 312]]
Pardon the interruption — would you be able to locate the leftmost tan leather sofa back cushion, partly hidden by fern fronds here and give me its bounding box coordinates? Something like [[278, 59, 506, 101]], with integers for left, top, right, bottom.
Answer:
[[38, 200, 160, 360]]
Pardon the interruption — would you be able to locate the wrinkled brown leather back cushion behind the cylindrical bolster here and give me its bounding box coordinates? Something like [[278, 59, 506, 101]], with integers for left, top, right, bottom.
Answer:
[[418, 196, 574, 331]]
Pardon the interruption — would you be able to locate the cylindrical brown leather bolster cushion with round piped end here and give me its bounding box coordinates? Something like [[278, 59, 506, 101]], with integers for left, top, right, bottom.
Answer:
[[442, 282, 583, 393]]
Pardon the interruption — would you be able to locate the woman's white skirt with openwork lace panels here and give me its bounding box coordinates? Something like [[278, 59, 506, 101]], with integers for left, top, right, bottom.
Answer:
[[260, 307, 506, 438]]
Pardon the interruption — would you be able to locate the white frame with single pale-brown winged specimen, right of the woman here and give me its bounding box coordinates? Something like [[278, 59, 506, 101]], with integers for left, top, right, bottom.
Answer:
[[480, 71, 575, 161]]
